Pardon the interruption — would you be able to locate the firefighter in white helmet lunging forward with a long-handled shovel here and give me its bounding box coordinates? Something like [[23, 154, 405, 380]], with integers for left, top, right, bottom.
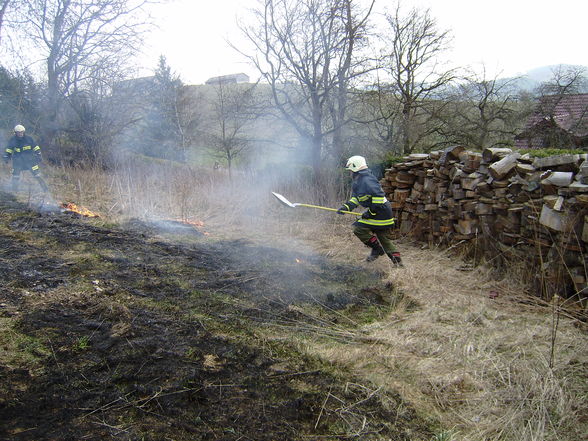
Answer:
[[337, 156, 403, 266]]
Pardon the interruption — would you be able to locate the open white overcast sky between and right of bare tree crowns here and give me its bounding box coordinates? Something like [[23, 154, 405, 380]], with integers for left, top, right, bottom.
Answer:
[[142, 0, 588, 84]]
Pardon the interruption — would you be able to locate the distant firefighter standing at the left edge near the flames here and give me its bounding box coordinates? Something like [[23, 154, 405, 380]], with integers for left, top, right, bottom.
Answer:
[[3, 124, 49, 191]]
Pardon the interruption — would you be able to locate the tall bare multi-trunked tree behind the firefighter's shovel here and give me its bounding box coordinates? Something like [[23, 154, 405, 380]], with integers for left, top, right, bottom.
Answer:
[[242, 0, 373, 175]]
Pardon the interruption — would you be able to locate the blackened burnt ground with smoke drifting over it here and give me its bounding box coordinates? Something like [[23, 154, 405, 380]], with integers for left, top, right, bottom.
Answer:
[[0, 192, 433, 441]]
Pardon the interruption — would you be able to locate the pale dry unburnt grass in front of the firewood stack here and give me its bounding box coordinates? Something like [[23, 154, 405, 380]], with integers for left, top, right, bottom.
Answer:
[[313, 234, 588, 441]]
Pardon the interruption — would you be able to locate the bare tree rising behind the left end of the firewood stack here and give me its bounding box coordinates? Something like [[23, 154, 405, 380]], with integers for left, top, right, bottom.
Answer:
[[379, 3, 455, 154]]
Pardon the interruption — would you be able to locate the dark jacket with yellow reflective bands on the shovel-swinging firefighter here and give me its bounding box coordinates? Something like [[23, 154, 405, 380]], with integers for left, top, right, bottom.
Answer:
[[343, 169, 394, 230]]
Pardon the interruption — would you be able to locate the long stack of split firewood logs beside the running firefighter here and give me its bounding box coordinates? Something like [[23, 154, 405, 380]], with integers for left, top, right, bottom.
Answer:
[[381, 146, 588, 295]]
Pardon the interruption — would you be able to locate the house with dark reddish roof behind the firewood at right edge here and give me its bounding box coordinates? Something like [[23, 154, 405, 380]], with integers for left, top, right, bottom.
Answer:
[[515, 93, 588, 149]]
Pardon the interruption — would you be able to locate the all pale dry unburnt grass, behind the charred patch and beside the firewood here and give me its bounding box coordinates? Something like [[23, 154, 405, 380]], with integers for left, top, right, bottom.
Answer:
[[11, 164, 588, 441]]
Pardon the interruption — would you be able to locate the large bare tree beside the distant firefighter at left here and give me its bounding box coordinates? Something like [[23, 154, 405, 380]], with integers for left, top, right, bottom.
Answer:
[[16, 0, 154, 155]]
